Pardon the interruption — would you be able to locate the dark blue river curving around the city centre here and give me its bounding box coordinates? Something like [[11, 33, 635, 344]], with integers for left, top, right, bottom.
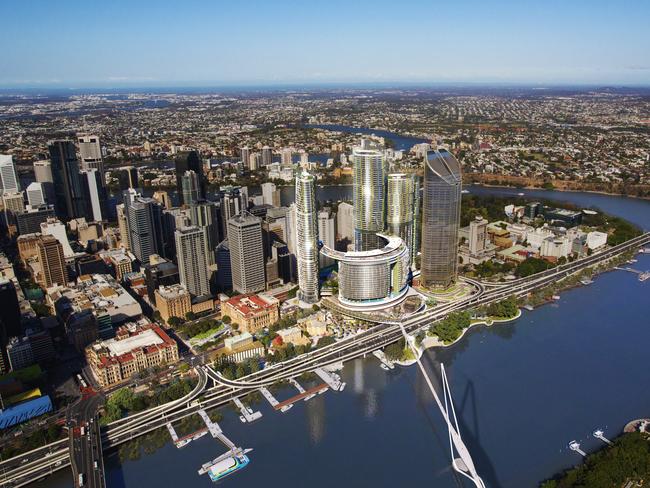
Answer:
[[42, 127, 650, 488]]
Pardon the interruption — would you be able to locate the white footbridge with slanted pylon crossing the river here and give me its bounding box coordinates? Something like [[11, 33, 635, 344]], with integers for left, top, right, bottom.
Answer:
[[400, 324, 486, 488]]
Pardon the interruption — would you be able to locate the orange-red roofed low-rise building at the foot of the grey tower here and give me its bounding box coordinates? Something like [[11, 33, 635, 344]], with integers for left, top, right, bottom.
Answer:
[[221, 295, 280, 333]]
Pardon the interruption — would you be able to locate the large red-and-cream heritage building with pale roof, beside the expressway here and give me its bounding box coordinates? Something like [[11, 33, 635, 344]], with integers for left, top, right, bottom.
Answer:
[[86, 323, 178, 386]]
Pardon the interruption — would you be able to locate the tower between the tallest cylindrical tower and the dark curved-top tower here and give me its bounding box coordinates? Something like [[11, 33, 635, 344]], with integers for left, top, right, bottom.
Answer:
[[386, 173, 415, 262]]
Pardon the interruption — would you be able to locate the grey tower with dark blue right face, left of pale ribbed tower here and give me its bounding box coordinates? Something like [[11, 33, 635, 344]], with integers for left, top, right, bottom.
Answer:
[[124, 190, 164, 264]]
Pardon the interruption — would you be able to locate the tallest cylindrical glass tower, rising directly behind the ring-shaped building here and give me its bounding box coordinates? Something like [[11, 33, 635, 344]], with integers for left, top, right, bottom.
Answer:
[[352, 140, 385, 251]]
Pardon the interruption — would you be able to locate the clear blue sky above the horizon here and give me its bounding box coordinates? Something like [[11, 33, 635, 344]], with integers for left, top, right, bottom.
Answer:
[[0, 0, 650, 88]]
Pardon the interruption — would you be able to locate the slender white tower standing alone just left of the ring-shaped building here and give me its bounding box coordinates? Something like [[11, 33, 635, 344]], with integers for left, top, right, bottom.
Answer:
[[296, 171, 318, 303]]
